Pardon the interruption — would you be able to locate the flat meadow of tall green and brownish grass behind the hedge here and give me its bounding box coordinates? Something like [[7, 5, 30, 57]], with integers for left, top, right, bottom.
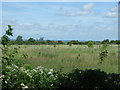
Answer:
[[13, 45, 118, 73]]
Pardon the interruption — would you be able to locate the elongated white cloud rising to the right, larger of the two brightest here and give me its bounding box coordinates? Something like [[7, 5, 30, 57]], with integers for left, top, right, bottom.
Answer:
[[59, 3, 94, 16]]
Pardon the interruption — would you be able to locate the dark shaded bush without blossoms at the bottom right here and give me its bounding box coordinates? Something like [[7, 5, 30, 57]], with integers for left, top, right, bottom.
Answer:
[[56, 69, 120, 90]]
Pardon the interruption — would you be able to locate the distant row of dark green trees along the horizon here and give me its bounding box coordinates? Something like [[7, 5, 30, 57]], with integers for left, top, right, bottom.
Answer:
[[0, 36, 120, 45]]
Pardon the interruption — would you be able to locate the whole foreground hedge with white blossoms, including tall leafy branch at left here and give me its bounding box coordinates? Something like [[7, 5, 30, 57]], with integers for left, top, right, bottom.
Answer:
[[0, 25, 120, 90]]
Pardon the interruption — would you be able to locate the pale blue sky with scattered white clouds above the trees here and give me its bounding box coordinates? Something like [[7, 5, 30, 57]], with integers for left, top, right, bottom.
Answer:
[[2, 2, 118, 40]]
